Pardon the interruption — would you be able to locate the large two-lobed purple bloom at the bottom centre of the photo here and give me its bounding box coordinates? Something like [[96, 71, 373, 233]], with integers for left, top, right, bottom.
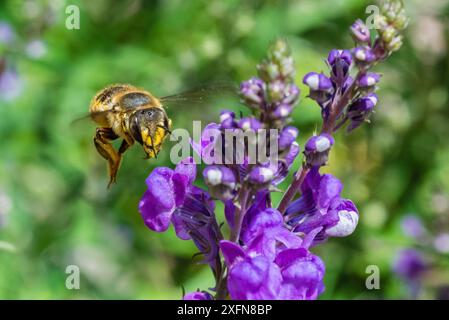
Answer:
[[220, 241, 325, 300]]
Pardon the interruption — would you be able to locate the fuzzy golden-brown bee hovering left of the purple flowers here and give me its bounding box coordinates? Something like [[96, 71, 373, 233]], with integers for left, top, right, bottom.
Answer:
[[89, 84, 172, 188]]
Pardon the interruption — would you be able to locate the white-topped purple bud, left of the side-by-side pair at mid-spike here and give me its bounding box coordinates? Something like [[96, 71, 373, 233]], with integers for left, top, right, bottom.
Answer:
[[203, 165, 236, 201]]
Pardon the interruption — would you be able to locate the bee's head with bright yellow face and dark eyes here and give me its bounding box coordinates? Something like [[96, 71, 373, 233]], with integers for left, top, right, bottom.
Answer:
[[130, 107, 171, 158]]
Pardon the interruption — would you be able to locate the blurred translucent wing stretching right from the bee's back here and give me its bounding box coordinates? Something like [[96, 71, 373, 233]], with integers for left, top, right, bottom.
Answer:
[[160, 82, 238, 106]]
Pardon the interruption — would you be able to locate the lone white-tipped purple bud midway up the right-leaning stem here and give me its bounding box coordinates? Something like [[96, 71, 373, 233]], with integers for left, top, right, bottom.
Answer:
[[304, 133, 335, 166]]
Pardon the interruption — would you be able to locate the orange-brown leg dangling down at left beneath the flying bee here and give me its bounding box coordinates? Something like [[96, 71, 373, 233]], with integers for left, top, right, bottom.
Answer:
[[94, 128, 120, 188]]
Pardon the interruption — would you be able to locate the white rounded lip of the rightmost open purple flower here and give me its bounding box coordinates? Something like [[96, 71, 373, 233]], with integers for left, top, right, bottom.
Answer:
[[325, 200, 359, 237]]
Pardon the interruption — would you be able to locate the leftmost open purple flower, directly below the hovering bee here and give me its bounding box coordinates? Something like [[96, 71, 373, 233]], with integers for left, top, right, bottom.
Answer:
[[139, 158, 196, 232]]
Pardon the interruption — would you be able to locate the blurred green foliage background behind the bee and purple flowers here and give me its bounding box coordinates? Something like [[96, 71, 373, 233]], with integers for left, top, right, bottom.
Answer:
[[0, 0, 449, 299]]
